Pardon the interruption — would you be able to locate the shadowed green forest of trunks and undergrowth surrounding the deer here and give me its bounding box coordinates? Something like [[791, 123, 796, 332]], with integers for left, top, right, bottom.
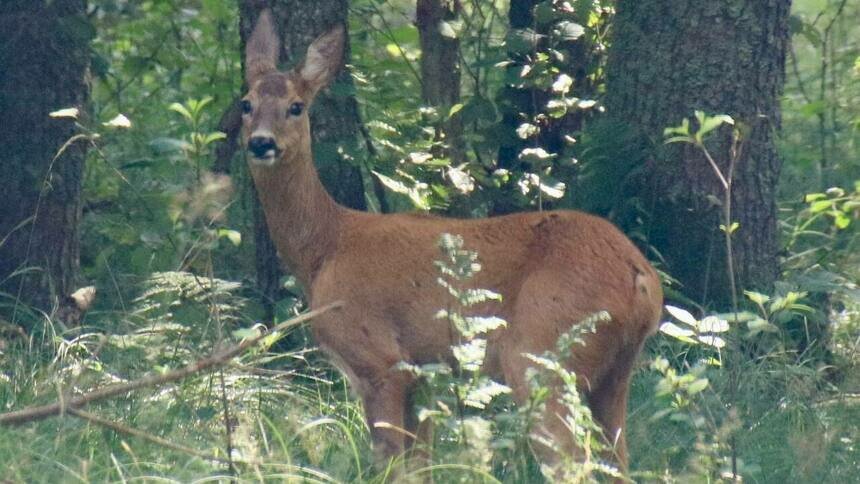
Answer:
[[0, 0, 860, 483]]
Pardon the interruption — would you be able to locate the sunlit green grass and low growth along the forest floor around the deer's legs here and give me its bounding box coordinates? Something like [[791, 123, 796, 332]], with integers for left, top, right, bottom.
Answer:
[[0, 279, 860, 484]]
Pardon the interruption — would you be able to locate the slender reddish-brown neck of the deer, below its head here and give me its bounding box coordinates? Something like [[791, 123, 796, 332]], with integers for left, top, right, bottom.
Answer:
[[251, 143, 347, 290]]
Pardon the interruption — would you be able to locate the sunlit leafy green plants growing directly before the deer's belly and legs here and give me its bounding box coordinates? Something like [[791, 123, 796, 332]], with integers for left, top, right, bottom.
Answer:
[[400, 234, 620, 482]]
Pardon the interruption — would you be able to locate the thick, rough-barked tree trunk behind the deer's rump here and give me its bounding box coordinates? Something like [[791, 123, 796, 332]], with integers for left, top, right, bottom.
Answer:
[[606, 0, 791, 306]]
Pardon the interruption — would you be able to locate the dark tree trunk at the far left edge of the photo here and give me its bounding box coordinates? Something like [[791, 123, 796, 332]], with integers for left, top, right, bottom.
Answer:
[[0, 0, 94, 322]]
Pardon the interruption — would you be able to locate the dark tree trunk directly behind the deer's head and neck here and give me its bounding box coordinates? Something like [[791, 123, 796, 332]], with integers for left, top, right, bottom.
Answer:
[[239, 0, 367, 316]]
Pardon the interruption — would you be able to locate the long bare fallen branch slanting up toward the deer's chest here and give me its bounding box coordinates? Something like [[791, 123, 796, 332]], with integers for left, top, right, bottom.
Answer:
[[0, 302, 342, 425]]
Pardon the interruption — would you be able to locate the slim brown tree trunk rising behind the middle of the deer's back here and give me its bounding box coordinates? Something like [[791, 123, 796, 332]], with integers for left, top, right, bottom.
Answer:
[[415, 0, 466, 165]]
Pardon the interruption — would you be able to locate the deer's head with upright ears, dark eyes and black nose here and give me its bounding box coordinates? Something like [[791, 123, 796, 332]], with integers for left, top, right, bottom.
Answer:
[[242, 9, 344, 167]]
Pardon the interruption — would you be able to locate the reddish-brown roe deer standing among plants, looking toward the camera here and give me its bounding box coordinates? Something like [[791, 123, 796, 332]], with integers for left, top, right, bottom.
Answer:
[[242, 9, 663, 478]]
